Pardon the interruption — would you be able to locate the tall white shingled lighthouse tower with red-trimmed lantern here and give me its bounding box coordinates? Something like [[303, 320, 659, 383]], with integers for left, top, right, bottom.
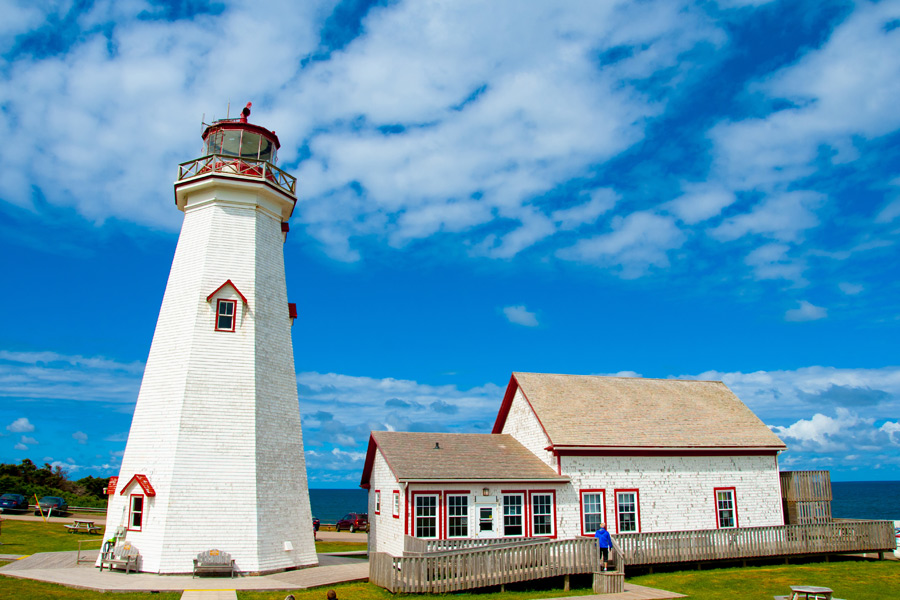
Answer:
[[104, 104, 318, 574]]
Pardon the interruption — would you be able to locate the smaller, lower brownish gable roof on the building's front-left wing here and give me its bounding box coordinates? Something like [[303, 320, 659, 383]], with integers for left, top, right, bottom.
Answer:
[[360, 431, 569, 488]]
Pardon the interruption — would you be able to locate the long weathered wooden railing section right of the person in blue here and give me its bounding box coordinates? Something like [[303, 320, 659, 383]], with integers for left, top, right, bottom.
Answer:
[[616, 521, 895, 565]]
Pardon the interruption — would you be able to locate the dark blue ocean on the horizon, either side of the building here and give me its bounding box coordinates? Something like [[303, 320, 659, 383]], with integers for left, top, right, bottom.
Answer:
[[309, 481, 900, 523]]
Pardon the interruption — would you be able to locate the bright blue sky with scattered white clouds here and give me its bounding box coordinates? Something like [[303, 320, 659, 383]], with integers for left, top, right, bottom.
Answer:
[[0, 0, 900, 487]]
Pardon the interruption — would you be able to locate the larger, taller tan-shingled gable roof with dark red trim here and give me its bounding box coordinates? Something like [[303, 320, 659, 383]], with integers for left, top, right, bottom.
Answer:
[[493, 373, 786, 451]]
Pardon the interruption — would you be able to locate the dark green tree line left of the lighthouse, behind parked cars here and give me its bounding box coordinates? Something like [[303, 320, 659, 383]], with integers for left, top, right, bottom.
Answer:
[[0, 458, 109, 508]]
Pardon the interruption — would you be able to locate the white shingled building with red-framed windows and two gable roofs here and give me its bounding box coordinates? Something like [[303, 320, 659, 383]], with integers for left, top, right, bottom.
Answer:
[[361, 373, 786, 556]]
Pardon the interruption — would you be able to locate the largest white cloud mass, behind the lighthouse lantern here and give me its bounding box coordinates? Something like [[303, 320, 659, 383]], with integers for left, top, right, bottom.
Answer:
[[0, 1, 726, 270]]
